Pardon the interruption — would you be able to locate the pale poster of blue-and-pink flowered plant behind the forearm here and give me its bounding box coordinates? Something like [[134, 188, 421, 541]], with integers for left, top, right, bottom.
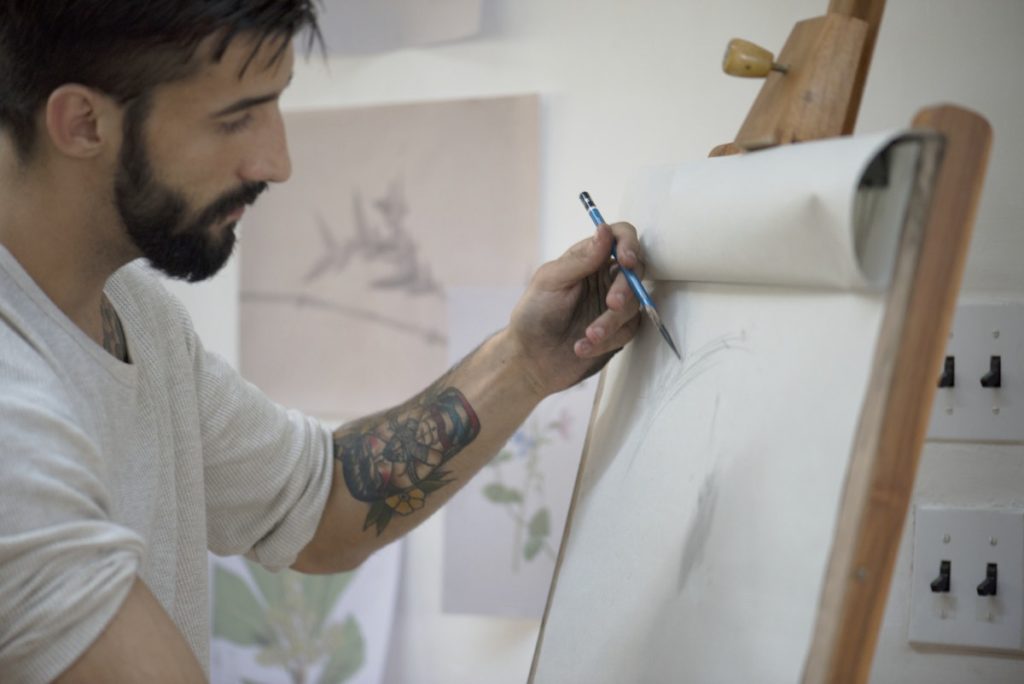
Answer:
[[441, 288, 596, 618]]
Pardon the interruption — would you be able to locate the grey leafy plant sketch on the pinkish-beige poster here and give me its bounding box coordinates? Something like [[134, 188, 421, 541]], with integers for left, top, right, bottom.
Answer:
[[302, 180, 444, 298]]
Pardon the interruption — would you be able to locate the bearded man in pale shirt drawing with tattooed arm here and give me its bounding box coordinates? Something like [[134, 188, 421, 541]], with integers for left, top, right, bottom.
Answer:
[[0, 0, 642, 682]]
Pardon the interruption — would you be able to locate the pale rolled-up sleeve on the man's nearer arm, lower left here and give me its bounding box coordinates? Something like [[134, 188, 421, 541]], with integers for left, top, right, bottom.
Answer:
[[0, 378, 143, 682]]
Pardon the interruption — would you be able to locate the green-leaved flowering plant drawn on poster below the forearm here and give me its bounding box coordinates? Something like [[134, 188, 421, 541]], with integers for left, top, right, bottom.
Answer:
[[483, 408, 572, 571]]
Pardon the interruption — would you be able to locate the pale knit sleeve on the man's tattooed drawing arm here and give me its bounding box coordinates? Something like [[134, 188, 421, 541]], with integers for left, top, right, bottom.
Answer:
[[178, 307, 334, 570]]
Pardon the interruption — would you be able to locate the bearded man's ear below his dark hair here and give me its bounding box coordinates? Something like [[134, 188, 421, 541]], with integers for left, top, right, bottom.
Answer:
[[45, 84, 121, 159]]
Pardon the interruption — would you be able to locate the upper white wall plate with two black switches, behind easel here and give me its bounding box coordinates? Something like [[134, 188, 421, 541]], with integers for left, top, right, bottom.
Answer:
[[928, 303, 1024, 442]]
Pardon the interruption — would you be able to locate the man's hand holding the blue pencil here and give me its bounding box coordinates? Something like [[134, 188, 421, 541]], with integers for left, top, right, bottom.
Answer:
[[509, 223, 644, 395]]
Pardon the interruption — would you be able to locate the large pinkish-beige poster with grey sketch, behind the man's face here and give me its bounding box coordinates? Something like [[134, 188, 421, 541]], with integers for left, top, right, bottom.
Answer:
[[240, 95, 540, 420]]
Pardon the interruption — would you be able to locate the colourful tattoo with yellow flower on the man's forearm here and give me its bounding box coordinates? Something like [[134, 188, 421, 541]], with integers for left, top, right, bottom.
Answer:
[[334, 380, 480, 535]]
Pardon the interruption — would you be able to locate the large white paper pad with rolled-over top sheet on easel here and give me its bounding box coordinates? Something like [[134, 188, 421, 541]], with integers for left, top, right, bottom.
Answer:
[[534, 134, 937, 684]]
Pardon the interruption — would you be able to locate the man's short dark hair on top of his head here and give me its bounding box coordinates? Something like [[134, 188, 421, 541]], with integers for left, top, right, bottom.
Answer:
[[0, 0, 323, 163]]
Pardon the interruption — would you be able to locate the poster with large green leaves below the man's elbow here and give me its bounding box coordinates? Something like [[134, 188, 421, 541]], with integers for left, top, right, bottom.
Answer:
[[210, 544, 401, 684]]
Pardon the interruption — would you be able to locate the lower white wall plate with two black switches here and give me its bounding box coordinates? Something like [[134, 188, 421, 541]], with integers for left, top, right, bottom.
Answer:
[[908, 506, 1024, 652]]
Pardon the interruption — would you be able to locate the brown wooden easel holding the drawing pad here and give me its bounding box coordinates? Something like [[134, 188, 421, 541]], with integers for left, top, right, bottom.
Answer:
[[711, 0, 991, 682]]
